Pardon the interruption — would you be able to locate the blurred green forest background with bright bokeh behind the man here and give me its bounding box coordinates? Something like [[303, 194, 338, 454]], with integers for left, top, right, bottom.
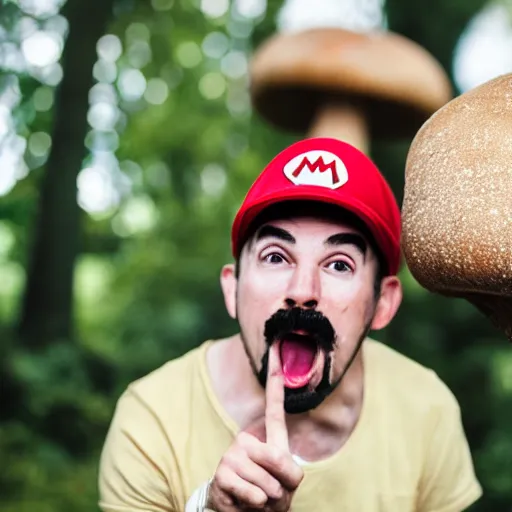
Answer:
[[0, 0, 512, 512]]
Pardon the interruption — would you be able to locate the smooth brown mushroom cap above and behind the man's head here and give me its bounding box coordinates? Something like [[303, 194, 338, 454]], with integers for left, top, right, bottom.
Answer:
[[250, 28, 452, 137]]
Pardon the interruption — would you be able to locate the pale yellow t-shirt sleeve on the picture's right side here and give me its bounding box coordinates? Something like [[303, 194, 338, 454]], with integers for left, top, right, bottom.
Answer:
[[418, 388, 482, 512]]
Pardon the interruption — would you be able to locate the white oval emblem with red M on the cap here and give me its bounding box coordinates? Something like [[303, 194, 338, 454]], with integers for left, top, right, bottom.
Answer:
[[283, 150, 348, 190]]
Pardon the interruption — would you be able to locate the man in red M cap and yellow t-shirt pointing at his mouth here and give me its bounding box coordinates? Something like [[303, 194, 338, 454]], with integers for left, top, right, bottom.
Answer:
[[100, 138, 481, 512]]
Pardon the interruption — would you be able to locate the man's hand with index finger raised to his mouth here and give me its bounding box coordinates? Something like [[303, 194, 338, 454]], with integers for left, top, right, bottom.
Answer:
[[208, 344, 304, 512]]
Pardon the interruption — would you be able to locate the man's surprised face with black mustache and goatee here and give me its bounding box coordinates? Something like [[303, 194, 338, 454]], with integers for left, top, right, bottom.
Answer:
[[230, 217, 377, 413]]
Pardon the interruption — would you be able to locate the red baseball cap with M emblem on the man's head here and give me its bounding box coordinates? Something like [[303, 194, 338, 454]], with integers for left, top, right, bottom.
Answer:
[[231, 138, 401, 275]]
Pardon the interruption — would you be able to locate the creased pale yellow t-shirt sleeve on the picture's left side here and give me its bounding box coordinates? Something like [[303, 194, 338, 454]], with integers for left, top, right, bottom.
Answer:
[[98, 389, 180, 512]]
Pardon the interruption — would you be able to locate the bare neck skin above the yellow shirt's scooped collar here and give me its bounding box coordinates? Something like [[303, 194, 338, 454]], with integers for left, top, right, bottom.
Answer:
[[207, 335, 364, 458]]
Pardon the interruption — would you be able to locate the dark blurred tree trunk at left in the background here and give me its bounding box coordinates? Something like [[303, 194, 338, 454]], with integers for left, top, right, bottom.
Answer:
[[18, 0, 113, 348]]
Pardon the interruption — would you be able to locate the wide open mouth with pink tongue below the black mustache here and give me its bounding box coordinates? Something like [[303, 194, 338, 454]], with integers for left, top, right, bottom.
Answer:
[[278, 331, 325, 388]]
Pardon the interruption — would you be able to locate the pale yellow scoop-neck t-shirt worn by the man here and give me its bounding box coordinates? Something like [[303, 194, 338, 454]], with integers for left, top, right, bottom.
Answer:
[[99, 340, 482, 512]]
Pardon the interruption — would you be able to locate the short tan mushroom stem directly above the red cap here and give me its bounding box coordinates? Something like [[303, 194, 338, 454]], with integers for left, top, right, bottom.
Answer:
[[309, 102, 369, 154]]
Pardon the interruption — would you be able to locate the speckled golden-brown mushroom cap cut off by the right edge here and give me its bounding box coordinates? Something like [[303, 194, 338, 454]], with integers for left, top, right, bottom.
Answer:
[[402, 74, 512, 300]]
